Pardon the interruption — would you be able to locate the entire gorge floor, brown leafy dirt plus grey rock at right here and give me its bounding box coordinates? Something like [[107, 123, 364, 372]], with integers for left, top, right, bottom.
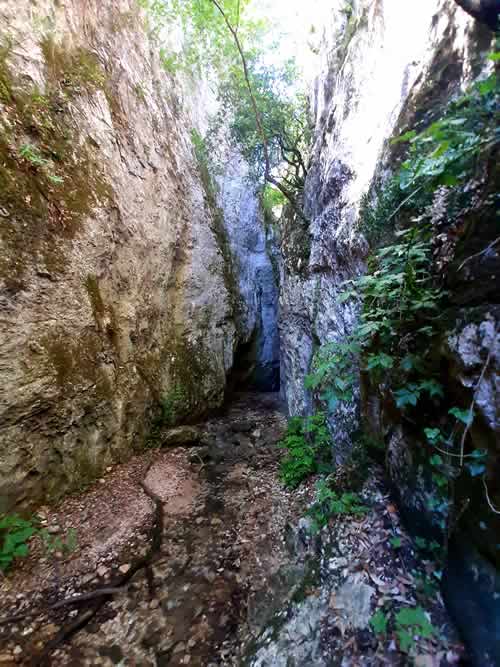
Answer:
[[0, 394, 461, 667]]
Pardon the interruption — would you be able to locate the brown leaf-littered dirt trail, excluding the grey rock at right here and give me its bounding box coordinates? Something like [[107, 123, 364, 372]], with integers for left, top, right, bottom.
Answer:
[[0, 394, 308, 667]]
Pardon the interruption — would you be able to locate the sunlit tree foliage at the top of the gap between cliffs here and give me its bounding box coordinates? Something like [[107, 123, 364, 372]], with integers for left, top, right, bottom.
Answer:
[[141, 0, 310, 206]]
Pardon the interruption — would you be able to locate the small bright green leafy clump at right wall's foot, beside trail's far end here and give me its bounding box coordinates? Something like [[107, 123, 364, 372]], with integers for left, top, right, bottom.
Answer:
[[279, 413, 331, 488]]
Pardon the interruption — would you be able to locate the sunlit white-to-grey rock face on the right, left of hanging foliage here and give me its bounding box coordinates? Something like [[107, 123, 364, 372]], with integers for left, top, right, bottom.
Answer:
[[280, 0, 477, 453]]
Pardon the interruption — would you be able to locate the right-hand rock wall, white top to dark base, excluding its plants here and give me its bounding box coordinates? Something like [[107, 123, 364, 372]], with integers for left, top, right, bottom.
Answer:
[[280, 0, 500, 665]]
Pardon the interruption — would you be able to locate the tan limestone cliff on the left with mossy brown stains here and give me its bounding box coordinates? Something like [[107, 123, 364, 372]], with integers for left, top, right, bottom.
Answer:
[[0, 0, 276, 510]]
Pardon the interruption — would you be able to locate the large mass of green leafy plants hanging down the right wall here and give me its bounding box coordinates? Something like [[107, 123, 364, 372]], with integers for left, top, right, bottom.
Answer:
[[305, 68, 500, 529]]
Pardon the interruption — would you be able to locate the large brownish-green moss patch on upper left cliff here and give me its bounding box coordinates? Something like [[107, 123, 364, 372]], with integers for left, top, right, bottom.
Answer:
[[0, 38, 113, 292]]
